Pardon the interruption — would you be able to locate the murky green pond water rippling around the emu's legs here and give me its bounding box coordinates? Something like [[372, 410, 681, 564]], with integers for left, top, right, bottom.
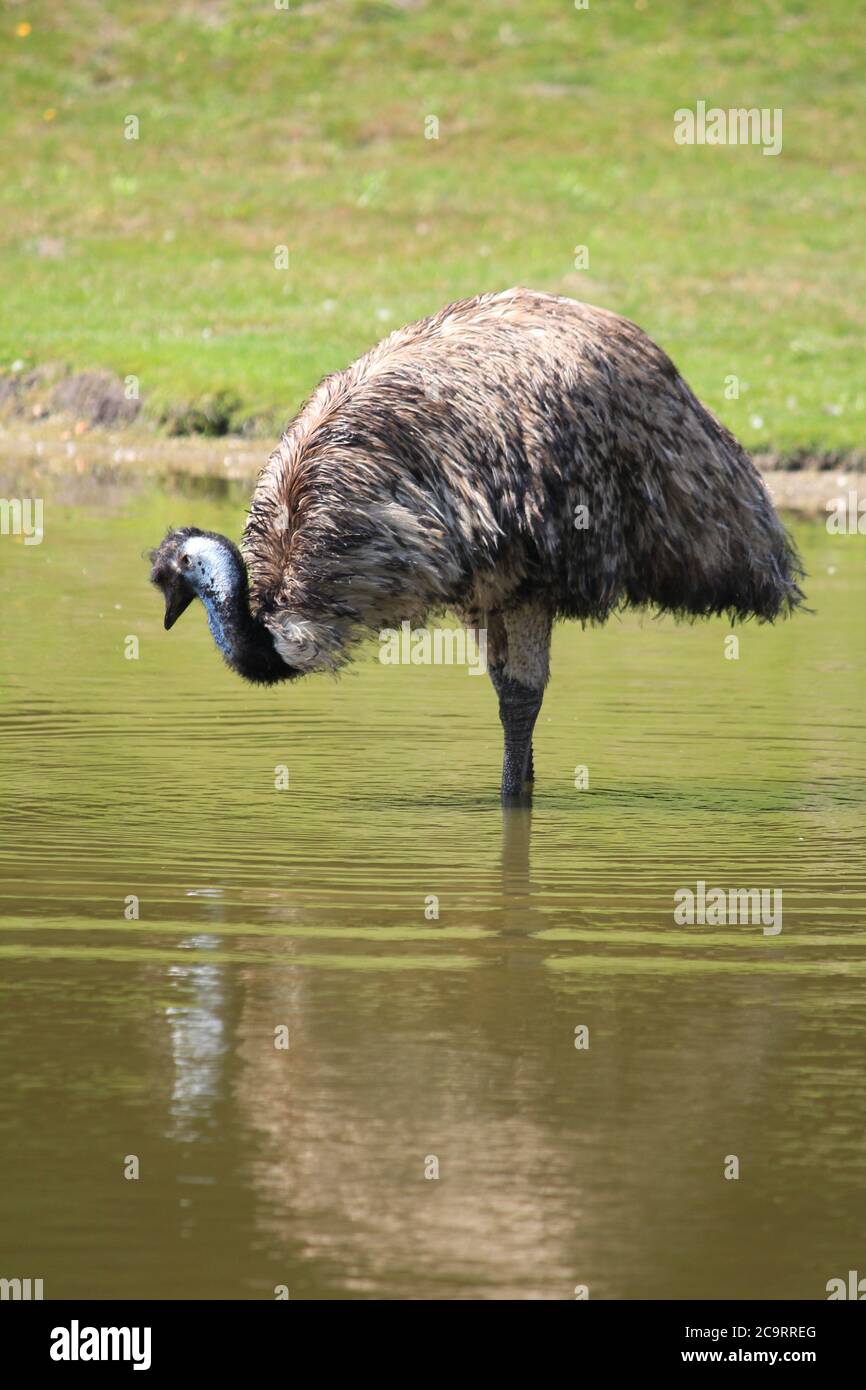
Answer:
[[0, 489, 866, 1298]]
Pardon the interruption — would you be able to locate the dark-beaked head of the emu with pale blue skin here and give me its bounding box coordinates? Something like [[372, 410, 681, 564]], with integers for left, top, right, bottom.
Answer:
[[150, 525, 246, 628]]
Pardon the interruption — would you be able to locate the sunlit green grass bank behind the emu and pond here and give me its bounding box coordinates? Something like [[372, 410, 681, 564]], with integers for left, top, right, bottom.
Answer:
[[0, 0, 866, 449]]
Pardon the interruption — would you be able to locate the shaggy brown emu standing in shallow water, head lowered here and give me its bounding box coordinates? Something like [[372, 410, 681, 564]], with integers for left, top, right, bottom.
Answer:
[[150, 288, 803, 805]]
